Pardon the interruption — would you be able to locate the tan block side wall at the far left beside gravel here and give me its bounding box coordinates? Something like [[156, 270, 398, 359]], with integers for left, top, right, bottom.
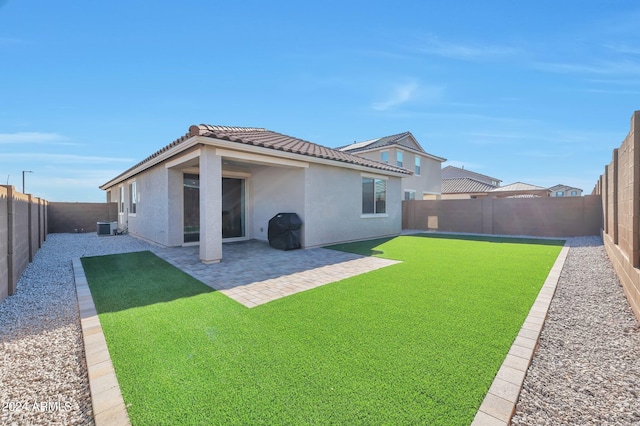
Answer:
[[0, 185, 47, 301]]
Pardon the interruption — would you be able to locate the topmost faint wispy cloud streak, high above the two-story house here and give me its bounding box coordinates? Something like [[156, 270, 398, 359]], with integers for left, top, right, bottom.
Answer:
[[416, 36, 519, 61]]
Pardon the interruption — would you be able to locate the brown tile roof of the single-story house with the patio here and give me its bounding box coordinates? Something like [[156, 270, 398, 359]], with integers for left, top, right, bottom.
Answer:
[[121, 124, 413, 184]]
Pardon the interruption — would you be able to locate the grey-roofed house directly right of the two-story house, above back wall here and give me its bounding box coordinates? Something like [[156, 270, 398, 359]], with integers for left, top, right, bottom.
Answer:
[[442, 166, 502, 200]]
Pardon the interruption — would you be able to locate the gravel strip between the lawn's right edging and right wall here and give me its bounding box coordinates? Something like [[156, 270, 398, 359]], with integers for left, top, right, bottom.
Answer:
[[512, 237, 640, 425]]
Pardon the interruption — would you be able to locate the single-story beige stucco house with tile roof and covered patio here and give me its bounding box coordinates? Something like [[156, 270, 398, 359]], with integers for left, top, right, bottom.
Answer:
[[100, 125, 411, 263]]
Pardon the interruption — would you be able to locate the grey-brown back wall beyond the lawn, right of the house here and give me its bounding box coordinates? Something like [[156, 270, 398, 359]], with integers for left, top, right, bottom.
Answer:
[[402, 195, 602, 237]]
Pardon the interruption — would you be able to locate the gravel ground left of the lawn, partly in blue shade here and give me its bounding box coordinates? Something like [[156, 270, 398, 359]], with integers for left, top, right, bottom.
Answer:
[[0, 234, 151, 425]]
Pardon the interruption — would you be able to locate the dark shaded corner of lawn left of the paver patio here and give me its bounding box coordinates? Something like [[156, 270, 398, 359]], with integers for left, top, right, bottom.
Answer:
[[81, 251, 215, 314]]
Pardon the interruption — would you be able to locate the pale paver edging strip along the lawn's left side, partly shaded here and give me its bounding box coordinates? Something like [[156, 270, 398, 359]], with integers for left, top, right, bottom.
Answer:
[[72, 259, 131, 426]]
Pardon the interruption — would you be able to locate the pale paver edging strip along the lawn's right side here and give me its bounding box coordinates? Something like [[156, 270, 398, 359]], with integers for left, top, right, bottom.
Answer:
[[471, 242, 569, 426]]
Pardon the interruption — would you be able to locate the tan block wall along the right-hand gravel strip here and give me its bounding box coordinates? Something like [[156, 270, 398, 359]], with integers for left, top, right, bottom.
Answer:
[[594, 111, 640, 320]]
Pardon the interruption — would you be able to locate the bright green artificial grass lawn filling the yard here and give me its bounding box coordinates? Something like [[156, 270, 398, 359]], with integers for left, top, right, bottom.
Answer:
[[82, 236, 562, 425]]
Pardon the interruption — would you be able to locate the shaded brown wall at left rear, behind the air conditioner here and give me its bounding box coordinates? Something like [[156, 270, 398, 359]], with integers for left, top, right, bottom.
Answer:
[[47, 202, 118, 233]]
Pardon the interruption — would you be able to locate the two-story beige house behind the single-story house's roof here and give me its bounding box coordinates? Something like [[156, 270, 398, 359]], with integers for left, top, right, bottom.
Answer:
[[338, 132, 447, 200]]
